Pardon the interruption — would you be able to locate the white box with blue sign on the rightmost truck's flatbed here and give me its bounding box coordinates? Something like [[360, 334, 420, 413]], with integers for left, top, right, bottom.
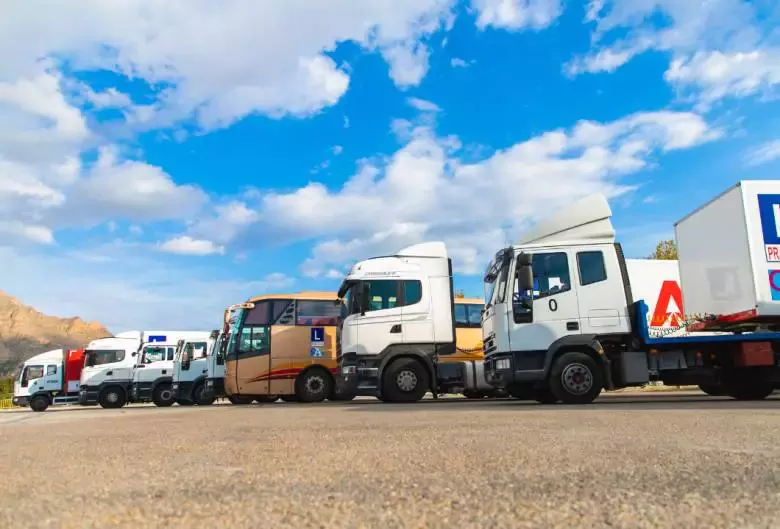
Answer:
[[675, 180, 780, 325]]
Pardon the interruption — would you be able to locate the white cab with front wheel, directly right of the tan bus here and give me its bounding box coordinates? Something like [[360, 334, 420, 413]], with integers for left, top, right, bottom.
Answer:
[[337, 242, 456, 402]]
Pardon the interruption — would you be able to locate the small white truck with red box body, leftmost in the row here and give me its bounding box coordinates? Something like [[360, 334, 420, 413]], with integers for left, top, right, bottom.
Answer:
[[13, 349, 84, 411]]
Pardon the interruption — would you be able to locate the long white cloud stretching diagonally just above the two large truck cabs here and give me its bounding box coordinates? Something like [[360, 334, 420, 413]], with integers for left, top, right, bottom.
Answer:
[[219, 106, 722, 277]]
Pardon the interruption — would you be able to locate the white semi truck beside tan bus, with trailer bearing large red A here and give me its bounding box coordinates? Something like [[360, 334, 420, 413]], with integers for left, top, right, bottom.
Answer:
[[337, 243, 682, 400]]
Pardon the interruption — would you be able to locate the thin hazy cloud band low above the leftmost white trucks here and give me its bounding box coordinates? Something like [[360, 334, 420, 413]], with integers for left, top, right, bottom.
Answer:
[[0, 244, 295, 332]]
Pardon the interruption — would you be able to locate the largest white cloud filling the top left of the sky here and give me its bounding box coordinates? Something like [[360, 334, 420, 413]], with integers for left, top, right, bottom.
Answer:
[[0, 0, 453, 129]]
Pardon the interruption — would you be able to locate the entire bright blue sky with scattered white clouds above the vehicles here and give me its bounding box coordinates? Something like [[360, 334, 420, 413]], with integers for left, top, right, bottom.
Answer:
[[0, 0, 780, 331]]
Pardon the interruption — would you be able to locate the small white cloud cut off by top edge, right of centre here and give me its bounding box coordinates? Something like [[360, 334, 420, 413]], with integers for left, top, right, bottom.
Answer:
[[471, 0, 563, 30]]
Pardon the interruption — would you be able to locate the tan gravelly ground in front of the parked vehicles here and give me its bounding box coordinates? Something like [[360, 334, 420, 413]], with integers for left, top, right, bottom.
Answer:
[[0, 394, 780, 529]]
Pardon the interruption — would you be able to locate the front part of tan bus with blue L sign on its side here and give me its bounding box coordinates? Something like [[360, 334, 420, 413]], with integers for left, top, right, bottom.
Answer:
[[224, 292, 354, 403]]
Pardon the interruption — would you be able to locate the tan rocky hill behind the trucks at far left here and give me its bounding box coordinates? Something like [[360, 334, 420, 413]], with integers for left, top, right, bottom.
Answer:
[[0, 290, 111, 376]]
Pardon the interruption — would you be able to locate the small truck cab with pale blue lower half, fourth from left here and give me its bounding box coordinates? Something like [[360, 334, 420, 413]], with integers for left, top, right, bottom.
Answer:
[[173, 330, 219, 406]]
